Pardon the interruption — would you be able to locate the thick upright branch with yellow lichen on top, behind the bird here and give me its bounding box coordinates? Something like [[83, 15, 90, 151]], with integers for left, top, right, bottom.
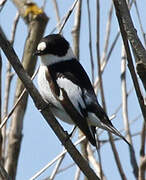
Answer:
[[5, 0, 48, 179]]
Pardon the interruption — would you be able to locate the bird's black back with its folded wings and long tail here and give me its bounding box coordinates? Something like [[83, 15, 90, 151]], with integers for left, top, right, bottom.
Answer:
[[48, 59, 128, 145]]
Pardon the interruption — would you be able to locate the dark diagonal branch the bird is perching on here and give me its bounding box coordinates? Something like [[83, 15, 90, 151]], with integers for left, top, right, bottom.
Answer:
[[0, 29, 99, 180]]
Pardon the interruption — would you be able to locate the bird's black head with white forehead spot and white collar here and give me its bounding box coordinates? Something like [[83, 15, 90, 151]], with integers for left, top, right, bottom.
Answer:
[[34, 34, 74, 65]]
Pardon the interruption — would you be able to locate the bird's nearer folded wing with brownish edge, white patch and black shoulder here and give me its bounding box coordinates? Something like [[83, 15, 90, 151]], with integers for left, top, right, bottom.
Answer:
[[48, 60, 99, 145]]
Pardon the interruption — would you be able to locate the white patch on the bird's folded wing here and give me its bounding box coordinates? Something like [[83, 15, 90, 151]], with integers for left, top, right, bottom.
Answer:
[[57, 77, 85, 115]]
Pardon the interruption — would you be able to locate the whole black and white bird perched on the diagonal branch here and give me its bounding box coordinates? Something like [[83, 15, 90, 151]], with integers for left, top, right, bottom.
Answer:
[[35, 34, 129, 146]]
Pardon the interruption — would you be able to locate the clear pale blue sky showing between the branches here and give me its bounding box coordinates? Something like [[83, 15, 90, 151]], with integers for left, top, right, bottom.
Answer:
[[0, 0, 146, 180]]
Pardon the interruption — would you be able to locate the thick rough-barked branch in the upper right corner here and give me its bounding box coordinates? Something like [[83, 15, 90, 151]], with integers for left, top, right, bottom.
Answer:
[[113, 0, 146, 89]]
